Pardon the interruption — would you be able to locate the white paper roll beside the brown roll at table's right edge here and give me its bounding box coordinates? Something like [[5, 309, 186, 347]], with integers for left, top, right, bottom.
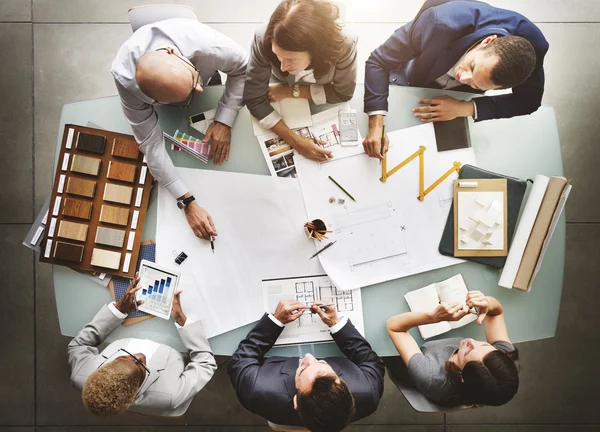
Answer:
[[498, 175, 550, 289]]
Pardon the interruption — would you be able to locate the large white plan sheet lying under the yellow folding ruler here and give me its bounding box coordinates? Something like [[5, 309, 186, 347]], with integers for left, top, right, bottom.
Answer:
[[296, 124, 476, 289]]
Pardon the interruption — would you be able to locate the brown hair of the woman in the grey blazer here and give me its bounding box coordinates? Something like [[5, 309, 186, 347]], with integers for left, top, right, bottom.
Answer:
[[261, 0, 345, 79]]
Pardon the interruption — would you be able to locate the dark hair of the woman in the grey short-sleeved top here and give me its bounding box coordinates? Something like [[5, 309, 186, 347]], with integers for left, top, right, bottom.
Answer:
[[441, 349, 519, 406]]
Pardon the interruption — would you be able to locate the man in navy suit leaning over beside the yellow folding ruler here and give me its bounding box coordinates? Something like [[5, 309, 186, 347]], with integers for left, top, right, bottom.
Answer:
[[363, 0, 548, 159]]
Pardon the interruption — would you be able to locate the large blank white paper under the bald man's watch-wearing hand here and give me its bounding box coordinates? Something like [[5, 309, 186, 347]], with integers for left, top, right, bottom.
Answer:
[[156, 168, 324, 337]]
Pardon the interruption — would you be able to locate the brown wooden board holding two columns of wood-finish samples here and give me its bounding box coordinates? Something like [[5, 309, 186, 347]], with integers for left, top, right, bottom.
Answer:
[[40, 124, 153, 277]]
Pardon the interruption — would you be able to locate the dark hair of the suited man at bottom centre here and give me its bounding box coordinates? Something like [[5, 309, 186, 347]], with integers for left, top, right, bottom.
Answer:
[[297, 375, 354, 432]]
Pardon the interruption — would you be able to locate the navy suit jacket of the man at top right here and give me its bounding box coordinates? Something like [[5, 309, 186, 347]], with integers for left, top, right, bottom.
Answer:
[[365, 0, 548, 121]]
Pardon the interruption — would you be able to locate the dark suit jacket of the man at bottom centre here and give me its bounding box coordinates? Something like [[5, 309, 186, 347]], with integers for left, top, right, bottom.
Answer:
[[227, 314, 385, 426]]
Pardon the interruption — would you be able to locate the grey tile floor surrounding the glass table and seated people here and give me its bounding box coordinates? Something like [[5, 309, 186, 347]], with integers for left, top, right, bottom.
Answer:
[[0, 0, 600, 432]]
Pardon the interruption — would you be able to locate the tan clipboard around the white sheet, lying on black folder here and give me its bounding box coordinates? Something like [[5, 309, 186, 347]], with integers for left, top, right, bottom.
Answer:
[[453, 178, 508, 257]]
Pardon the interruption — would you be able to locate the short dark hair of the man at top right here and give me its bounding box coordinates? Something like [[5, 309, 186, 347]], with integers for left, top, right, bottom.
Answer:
[[484, 36, 536, 88]]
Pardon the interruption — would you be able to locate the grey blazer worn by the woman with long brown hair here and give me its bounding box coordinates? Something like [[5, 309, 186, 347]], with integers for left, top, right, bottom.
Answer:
[[244, 24, 358, 120]]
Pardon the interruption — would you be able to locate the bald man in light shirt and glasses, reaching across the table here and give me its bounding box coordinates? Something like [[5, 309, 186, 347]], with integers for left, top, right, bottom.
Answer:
[[111, 18, 248, 240]]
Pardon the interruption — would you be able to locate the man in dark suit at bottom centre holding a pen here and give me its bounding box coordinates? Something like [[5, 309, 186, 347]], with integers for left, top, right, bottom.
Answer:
[[228, 300, 385, 432]]
